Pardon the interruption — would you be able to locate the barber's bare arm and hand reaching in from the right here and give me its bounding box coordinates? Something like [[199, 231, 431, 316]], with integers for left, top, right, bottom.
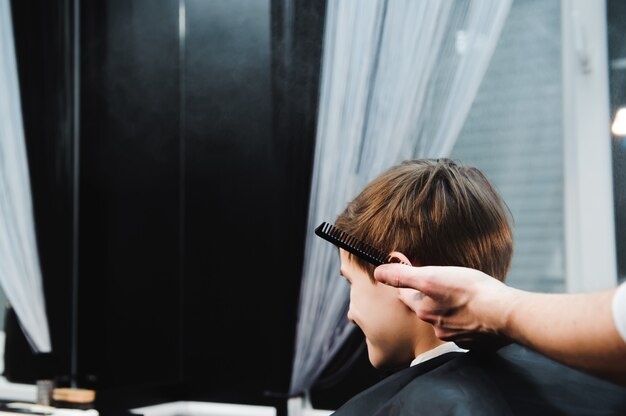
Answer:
[[375, 264, 626, 385]]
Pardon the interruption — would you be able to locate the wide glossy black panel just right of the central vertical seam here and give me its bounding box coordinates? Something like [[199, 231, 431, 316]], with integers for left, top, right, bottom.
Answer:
[[184, 0, 282, 402]]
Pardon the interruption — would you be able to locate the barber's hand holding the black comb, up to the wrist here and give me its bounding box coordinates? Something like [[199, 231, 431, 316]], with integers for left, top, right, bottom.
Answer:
[[374, 264, 515, 350]]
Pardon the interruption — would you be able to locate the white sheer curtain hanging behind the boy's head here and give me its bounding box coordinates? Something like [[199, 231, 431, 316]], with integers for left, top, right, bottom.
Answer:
[[291, 0, 511, 400]]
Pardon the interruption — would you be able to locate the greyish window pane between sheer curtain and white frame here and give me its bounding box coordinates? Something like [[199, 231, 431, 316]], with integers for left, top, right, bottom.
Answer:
[[452, 0, 565, 292]]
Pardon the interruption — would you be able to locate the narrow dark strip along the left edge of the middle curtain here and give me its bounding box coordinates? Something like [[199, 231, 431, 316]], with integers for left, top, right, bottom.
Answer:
[[270, 0, 326, 404]]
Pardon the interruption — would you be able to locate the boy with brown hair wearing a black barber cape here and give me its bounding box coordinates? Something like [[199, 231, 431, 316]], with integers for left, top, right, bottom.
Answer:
[[322, 159, 623, 416]]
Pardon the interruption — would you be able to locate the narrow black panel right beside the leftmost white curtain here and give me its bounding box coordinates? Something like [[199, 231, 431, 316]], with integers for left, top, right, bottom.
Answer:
[[7, 0, 74, 382]]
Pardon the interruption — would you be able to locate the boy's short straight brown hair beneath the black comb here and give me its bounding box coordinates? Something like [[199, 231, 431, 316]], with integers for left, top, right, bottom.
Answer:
[[335, 159, 513, 280]]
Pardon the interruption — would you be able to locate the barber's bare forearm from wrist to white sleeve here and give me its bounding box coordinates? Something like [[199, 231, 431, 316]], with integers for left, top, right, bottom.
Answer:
[[500, 290, 626, 384]]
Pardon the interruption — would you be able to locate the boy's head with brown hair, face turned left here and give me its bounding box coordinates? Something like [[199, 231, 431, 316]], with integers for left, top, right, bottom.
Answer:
[[335, 159, 513, 367]]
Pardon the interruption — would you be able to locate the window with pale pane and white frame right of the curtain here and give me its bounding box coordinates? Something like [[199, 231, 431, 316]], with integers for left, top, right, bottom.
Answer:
[[452, 0, 626, 292]]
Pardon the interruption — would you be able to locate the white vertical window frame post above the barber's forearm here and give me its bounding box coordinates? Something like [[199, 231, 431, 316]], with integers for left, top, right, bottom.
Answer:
[[561, 0, 617, 292]]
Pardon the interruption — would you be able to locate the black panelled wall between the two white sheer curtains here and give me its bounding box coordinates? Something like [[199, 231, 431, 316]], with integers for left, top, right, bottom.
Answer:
[[6, 0, 380, 414]]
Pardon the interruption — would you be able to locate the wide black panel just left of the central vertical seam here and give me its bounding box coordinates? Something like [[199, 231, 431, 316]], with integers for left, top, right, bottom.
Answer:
[[78, 0, 181, 389]]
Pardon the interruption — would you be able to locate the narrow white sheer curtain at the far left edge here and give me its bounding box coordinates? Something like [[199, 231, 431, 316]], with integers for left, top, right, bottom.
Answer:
[[0, 0, 51, 352]]
